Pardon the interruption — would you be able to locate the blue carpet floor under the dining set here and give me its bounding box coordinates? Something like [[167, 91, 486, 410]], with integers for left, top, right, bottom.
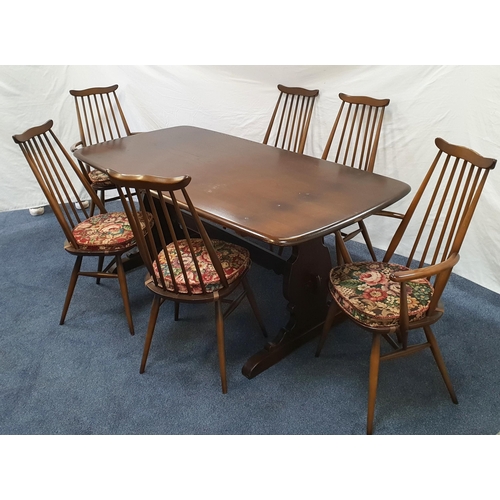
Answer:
[[0, 201, 500, 435]]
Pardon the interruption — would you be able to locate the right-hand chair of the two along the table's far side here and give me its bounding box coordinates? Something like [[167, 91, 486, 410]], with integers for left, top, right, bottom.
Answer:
[[321, 93, 390, 264]]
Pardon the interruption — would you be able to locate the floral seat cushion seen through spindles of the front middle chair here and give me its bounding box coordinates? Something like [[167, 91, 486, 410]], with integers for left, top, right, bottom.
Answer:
[[153, 238, 251, 294]]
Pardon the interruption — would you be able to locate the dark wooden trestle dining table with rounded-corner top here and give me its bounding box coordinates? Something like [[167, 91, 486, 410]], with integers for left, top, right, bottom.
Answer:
[[74, 126, 410, 378]]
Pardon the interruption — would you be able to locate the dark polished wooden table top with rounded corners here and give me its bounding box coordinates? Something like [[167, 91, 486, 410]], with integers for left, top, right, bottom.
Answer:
[[74, 126, 410, 246]]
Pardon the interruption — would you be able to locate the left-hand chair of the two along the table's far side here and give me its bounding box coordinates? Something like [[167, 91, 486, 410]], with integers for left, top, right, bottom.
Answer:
[[263, 85, 319, 154]]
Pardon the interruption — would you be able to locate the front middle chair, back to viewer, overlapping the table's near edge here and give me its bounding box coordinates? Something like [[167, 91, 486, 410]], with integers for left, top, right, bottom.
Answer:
[[108, 170, 267, 394]]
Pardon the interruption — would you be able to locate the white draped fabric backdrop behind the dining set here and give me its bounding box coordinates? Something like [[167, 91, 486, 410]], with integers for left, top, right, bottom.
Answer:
[[0, 66, 500, 292]]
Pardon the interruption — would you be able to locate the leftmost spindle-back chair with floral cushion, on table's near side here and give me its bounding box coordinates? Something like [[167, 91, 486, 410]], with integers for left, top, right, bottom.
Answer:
[[13, 120, 145, 335]]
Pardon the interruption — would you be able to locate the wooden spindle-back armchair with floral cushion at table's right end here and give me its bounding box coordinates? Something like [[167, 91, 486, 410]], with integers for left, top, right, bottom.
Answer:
[[316, 138, 496, 434]]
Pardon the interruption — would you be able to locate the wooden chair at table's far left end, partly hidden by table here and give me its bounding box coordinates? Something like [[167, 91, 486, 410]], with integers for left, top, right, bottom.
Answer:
[[69, 85, 137, 214]]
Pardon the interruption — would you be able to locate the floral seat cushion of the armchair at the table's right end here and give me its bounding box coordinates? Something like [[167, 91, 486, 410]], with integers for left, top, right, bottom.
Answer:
[[330, 262, 434, 328]]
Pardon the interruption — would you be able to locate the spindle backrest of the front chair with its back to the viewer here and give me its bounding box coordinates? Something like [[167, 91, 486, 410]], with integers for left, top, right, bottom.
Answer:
[[108, 171, 228, 295]]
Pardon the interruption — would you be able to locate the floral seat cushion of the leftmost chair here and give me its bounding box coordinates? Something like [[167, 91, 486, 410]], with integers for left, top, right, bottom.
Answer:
[[73, 212, 150, 251]]
